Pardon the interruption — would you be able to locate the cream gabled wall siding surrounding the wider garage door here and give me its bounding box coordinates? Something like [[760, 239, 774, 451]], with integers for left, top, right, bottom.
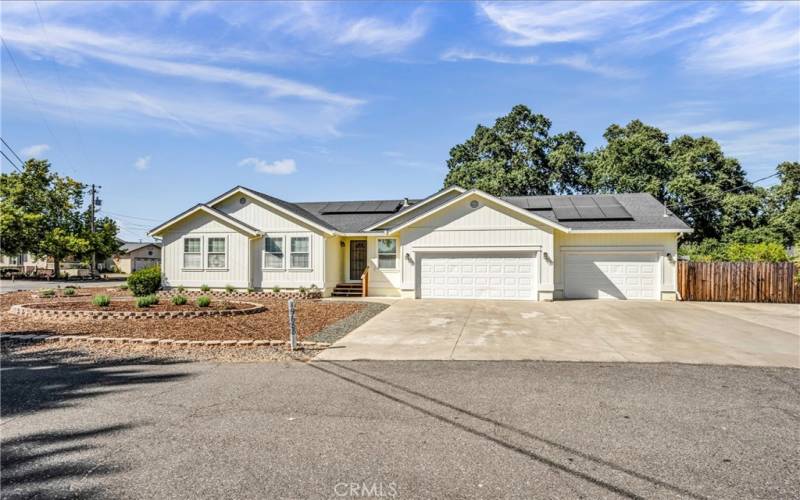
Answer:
[[400, 196, 553, 299]]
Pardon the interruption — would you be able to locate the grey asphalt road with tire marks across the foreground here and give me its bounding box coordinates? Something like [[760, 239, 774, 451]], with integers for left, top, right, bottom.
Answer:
[[2, 348, 800, 498]]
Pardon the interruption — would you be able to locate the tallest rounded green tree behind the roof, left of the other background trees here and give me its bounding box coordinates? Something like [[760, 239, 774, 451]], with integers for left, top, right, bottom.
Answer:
[[444, 105, 587, 196]]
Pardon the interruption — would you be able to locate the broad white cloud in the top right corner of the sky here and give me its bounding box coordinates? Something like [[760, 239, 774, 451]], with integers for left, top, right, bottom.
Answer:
[[686, 2, 800, 74]]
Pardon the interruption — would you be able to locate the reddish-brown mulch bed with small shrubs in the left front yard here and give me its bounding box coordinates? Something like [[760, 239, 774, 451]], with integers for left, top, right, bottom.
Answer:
[[0, 289, 365, 340]]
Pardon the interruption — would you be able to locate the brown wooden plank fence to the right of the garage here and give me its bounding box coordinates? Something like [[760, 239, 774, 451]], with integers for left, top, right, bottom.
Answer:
[[678, 261, 800, 303]]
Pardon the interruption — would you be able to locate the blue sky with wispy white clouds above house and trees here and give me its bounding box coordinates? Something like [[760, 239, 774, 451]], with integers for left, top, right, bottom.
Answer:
[[0, 2, 800, 240]]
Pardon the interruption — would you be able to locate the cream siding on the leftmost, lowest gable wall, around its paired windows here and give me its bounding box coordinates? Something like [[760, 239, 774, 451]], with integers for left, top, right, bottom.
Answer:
[[161, 214, 250, 288]]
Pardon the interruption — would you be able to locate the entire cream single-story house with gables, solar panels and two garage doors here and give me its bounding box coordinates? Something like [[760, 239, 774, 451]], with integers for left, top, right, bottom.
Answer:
[[151, 187, 691, 300]]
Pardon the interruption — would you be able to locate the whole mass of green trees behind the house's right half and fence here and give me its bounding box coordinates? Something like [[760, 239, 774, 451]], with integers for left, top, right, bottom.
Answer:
[[444, 105, 800, 252]]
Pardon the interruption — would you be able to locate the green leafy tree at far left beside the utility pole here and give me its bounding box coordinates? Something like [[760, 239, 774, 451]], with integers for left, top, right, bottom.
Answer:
[[0, 159, 119, 272]]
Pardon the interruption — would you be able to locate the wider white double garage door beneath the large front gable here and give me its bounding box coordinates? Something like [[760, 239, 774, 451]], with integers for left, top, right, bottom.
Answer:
[[419, 253, 536, 300]]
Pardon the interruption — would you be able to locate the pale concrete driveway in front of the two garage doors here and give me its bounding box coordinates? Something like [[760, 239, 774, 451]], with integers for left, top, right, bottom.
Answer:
[[317, 300, 800, 368]]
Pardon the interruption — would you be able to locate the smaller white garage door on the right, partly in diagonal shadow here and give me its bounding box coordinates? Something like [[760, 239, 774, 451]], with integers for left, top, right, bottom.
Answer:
[[564, 253, 659, 299]]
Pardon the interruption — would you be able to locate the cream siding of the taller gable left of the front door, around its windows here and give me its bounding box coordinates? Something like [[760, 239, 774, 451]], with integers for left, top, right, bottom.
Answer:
[[214, 194, 332, 289]]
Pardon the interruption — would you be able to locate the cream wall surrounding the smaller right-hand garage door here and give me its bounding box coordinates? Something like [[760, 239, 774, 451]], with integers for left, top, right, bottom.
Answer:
[[555, 231, 678, 299]]
